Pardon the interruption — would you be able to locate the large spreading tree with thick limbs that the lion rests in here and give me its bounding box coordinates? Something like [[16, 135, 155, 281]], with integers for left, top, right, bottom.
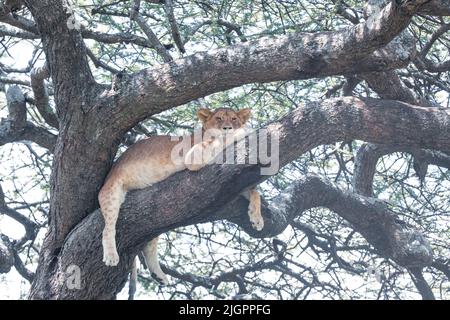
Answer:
[[0, 0, 450, 299]]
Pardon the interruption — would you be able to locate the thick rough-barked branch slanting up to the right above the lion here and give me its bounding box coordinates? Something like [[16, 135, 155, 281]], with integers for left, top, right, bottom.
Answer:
[[98, 1, 424, 134]]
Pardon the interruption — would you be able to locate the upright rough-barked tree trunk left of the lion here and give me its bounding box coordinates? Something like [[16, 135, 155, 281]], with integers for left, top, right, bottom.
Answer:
[[25, 0, 117, 298]]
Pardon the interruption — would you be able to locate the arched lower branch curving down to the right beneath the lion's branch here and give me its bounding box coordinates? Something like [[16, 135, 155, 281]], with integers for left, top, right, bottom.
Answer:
[[231, 176, 432, 267]]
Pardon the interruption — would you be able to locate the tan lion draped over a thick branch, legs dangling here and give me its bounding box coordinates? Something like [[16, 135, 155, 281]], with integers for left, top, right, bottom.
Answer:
[[98, 108, 264, 283]]
